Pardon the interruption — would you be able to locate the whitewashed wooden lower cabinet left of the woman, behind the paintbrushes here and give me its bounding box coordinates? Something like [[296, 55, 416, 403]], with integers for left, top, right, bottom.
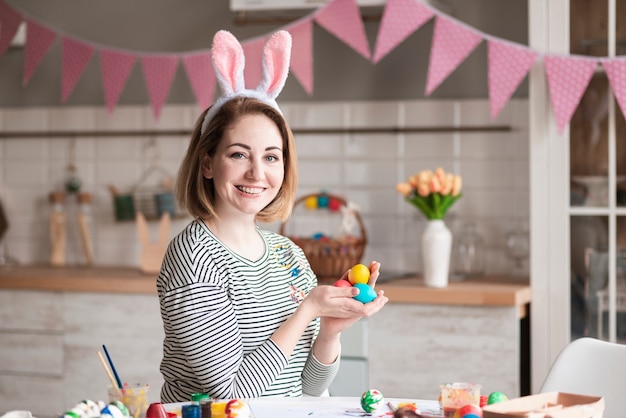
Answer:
[[0, 290, 163, 418]]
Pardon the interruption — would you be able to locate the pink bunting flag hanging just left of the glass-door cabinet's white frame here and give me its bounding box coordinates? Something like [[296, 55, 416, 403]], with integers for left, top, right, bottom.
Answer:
[[487, 40, 538, 119]]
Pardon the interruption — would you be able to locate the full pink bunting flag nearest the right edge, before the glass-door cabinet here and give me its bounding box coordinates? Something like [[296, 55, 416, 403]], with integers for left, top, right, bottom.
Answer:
[[544, 56, 598, 133]]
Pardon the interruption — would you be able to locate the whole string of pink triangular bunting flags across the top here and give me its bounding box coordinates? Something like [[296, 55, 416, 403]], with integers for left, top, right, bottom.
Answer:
[[0, 0, 626, 133]]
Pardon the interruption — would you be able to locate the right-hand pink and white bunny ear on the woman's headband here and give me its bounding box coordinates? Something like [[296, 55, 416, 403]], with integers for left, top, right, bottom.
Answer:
[[257, 30, 291, 99]]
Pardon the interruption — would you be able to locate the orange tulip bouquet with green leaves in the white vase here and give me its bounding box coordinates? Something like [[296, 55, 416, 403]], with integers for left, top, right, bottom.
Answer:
[[396, 167, 462, 220]]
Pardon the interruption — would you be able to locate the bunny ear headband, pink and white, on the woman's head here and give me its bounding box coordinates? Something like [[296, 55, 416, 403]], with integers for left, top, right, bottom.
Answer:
[[201, 30, 291, 132]]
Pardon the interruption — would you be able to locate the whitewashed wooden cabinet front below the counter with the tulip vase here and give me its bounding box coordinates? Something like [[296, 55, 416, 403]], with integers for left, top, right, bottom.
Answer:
[[369, 303, 522, 399]]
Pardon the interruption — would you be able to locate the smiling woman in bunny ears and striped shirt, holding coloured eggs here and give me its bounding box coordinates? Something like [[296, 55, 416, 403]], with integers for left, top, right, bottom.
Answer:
[[157, 32, 387, 403]]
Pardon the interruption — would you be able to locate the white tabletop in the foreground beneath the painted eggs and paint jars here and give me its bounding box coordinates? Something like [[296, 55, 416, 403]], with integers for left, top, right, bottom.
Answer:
[[164, 396, 443, 418]]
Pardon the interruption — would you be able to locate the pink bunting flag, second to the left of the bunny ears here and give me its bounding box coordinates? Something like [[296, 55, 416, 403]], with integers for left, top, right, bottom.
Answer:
[[141, 55, 178, 119]]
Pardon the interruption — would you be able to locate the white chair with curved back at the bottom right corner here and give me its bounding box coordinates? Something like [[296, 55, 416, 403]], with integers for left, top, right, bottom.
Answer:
[[540, 337, 626, 418]]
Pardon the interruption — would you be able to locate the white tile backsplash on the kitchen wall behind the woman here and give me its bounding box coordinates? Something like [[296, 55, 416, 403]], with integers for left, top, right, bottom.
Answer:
[[0, 100, 529, 280]]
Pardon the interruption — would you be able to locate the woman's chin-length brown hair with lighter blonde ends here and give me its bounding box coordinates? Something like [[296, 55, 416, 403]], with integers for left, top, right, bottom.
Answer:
[[176, 97, 298, 223]]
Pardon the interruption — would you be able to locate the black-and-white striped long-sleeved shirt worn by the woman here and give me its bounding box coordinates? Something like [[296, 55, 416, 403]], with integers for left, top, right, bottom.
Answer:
[[157, 220, 339, 403]]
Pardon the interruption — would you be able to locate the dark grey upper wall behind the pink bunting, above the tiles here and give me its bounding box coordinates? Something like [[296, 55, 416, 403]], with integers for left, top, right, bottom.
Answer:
[[0, 0, 528, 107]]
